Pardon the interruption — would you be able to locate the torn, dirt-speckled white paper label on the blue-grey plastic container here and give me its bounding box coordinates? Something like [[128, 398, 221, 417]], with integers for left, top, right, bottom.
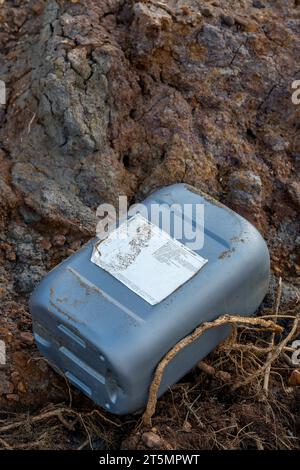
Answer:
[[91, 214, 207, 305]]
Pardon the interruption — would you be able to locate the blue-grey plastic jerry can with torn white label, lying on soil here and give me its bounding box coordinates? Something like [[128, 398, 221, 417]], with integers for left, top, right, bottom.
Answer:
[[30, 184, 270, 414]]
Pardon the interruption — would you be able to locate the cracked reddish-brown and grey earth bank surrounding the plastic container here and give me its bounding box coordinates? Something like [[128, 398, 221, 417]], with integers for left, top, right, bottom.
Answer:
[[0, 0, 300, 449]]
